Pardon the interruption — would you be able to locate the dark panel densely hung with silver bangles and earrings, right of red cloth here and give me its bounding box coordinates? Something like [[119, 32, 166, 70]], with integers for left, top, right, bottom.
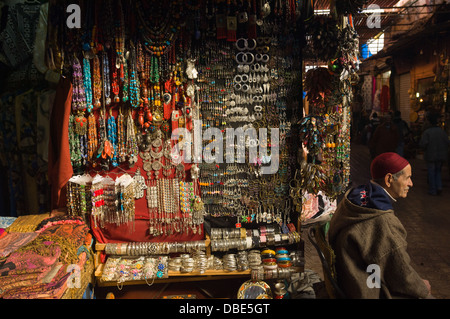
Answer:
[[198, 3, 301, 236]]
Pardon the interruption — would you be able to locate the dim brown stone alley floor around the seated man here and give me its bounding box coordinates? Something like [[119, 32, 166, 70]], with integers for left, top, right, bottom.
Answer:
[[303, 144, 450, 299]]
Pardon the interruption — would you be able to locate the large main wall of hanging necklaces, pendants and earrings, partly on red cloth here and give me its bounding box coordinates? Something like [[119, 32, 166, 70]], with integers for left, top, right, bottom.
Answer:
[[48, 0, 310, 288]]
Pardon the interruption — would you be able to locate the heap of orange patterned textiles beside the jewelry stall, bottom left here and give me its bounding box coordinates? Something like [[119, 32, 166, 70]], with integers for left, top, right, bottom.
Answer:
[[0, 216, 92, 299]]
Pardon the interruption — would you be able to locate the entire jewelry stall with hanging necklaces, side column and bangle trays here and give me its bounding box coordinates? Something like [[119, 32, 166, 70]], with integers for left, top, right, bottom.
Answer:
[[0, 0, 359, 298]]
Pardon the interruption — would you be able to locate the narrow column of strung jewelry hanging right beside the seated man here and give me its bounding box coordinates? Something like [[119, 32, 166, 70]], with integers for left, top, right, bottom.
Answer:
[[291, 7, 359, 222]]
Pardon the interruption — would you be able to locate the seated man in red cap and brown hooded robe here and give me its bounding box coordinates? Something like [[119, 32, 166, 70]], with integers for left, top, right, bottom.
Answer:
[[329, 152, 431, 299]]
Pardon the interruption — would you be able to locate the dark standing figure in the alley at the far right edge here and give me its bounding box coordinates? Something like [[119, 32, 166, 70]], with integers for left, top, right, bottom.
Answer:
[[419, 114, 449, 196]]
